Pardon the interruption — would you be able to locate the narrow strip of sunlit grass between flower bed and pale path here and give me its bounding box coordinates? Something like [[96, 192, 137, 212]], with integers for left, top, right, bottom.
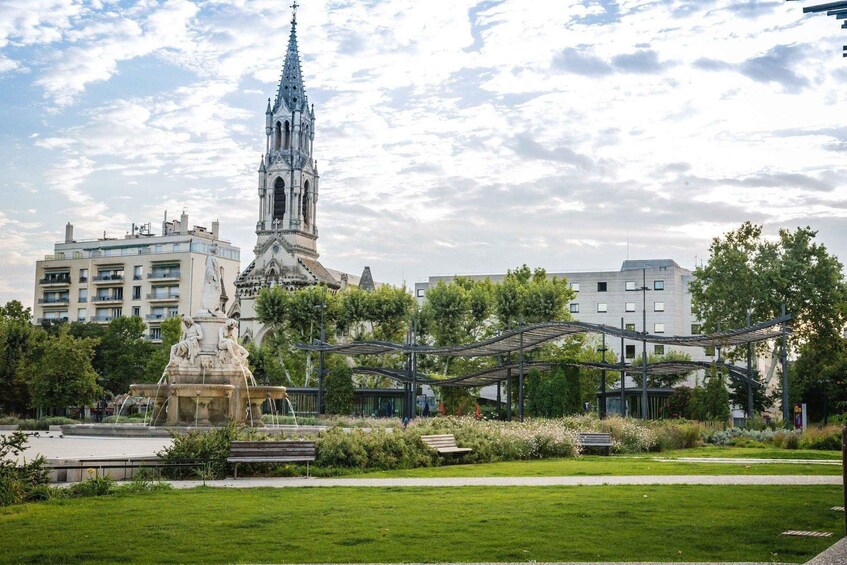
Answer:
[[347, 449, 841, 478]]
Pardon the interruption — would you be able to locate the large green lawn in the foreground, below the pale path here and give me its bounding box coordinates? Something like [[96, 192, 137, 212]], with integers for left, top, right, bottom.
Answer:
[[0, 486, 843, 563]]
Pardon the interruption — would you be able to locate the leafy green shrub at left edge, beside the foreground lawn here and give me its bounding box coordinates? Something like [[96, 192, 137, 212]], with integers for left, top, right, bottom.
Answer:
[[0, 432, 49, 506]]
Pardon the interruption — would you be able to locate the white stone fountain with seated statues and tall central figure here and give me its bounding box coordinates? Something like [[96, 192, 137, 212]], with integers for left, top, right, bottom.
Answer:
[[129, 255, 285, 427]]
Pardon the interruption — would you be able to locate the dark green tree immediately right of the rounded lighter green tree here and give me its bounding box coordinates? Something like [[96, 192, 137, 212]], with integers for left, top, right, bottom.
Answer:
[[94, 316, 156, 395]]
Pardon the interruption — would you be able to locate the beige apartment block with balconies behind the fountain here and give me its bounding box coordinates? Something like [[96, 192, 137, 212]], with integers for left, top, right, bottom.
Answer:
[[33, 212, 241, 341]]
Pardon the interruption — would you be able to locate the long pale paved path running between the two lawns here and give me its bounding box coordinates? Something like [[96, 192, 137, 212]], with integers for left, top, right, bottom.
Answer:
[[166, 475, 842, 488]]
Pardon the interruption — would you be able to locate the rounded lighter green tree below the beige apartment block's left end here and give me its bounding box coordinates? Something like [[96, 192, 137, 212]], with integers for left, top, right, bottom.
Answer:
[[25, 328, 101, 411]]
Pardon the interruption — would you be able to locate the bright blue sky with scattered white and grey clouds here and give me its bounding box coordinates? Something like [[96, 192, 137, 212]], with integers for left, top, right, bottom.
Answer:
[[0, 0, 847, 305]]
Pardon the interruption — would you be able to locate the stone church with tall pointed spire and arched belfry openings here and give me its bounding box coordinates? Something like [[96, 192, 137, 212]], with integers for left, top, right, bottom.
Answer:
[[234, 6, 374, 342]]
